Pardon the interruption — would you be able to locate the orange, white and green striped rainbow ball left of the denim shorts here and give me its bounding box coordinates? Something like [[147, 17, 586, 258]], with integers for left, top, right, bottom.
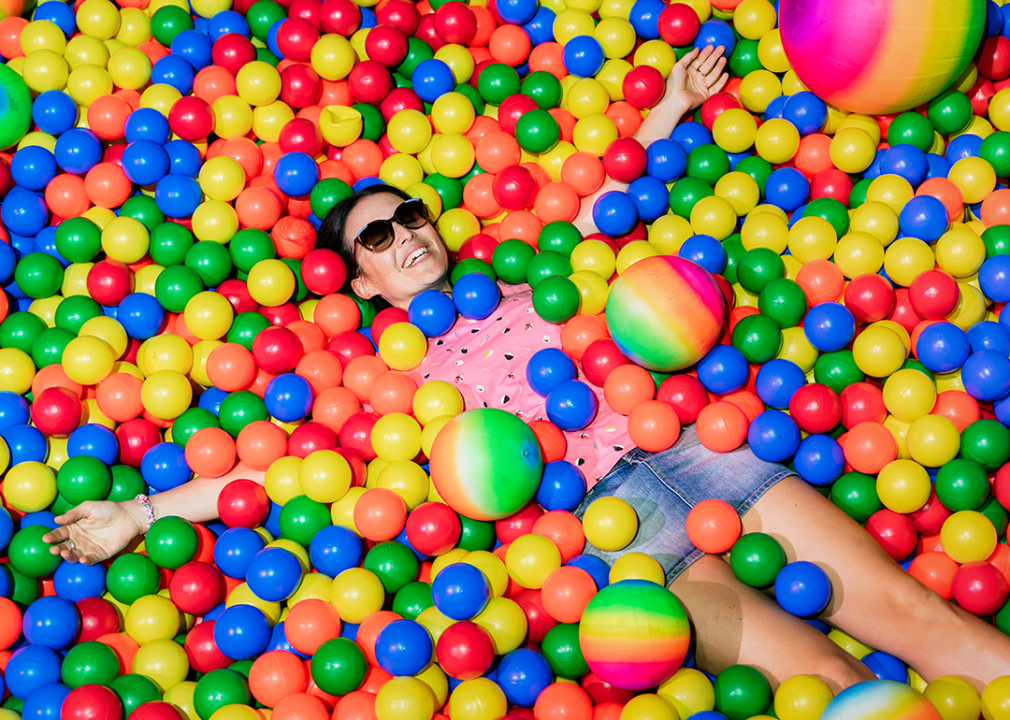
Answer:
[[430, 408, 543, 521]]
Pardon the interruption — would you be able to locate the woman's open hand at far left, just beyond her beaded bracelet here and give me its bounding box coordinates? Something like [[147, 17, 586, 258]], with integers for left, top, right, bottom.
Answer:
[[42, 500, 142, 565]]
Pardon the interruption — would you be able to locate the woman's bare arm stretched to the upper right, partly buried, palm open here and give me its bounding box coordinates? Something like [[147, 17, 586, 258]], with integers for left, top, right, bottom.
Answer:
[[575, 45, 729, 235]]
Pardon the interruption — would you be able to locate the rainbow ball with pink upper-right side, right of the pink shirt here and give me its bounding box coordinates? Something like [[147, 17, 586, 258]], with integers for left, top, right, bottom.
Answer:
[[607, 255, 726, 373]]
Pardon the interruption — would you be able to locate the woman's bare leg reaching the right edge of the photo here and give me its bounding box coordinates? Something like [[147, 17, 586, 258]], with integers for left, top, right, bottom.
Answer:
[[743, 477, 1010, 691]]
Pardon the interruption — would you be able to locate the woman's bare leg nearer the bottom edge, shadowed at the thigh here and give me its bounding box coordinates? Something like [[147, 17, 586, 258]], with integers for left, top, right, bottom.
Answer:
[[670, 555, 874, 693]]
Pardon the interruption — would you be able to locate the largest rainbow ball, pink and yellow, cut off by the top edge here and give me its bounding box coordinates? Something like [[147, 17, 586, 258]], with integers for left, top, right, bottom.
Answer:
[[779, 0, 986, 115]]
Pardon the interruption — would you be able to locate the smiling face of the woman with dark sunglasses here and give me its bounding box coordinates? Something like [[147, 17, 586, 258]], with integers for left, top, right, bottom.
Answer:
[[344, 193, 448, 309]]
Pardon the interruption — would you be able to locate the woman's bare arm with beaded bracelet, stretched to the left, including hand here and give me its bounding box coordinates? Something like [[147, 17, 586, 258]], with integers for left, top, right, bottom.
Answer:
[[42, 464, 267, 564]]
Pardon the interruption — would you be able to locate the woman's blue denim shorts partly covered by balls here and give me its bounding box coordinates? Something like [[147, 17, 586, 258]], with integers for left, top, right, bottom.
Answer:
[[575, 426, 794, 585]]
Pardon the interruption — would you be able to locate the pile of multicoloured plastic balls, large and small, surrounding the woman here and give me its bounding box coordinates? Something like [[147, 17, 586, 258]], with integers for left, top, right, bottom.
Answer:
[[0, 0, 1010, 720]]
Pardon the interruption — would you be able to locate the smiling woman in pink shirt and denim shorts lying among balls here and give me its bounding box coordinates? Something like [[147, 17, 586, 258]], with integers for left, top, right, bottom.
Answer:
[[43, 47, 1010, 692]]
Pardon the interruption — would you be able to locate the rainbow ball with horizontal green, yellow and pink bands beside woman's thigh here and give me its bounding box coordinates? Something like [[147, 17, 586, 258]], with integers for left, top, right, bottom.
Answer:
[[579, 580, 691, 691]]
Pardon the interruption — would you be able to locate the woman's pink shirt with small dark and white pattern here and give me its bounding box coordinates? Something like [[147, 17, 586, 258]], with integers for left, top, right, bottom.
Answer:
[[412, 283, 633, 487]]
